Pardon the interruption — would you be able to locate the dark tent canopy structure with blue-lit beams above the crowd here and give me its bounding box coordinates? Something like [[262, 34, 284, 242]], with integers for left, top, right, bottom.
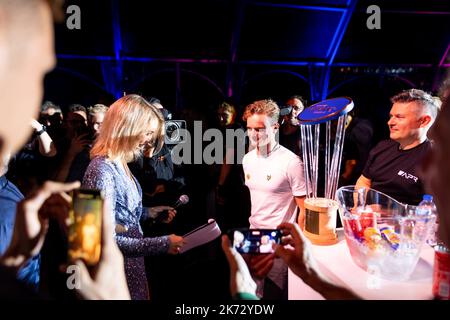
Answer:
[[47, 0, 450, 108]]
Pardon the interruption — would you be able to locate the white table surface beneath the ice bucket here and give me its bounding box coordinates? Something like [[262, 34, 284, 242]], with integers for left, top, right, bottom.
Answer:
[[288, 229, 434, 300]]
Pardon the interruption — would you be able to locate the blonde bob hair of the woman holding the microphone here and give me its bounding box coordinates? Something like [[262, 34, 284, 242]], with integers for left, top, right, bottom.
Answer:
[[90, 94, 164, 162]]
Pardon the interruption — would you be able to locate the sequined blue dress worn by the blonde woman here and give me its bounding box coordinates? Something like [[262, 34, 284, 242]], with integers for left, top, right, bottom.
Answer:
[[83, 156, 169, 300]]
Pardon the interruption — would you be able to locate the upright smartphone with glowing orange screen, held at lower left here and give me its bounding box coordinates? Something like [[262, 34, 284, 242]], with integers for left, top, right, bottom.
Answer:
[[68, 189, 104, 266]]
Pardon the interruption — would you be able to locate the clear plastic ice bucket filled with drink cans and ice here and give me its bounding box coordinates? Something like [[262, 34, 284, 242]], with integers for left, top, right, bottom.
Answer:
[[336, 186, 436, 281]]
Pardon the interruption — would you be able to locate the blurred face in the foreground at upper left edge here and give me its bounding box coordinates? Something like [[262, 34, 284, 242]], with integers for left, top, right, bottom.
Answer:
[[0, 1, 55, 154]]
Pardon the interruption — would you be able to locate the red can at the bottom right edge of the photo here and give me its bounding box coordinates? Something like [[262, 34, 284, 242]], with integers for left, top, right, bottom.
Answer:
[[433, 244, 450, 300]]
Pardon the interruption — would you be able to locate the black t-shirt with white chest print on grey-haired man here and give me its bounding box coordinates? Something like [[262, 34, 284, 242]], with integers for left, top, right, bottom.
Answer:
[[362, 140, 431, 205]]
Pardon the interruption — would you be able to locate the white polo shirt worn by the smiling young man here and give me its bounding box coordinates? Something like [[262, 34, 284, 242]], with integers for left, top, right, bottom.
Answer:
[[242, 145, 306, 229]]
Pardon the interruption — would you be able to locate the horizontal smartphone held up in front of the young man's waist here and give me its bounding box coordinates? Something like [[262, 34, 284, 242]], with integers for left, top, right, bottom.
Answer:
[[229, 229, 282, 254]]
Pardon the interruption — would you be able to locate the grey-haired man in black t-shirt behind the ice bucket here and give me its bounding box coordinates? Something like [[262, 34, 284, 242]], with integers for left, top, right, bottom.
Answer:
[[356, 89, 438, 205]]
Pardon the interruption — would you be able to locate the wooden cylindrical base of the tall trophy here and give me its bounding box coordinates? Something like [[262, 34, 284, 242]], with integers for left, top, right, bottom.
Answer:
[[303, 198, 338, 246]]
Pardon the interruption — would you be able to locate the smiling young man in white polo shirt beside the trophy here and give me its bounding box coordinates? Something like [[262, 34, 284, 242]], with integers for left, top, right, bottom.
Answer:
[[242, 100, 306, 299]]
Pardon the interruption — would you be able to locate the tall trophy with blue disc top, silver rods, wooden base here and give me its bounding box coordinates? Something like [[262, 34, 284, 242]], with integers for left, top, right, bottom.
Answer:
[[297, 97, 354, 245]]
